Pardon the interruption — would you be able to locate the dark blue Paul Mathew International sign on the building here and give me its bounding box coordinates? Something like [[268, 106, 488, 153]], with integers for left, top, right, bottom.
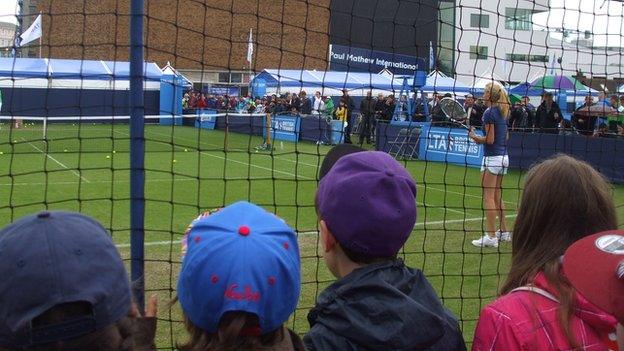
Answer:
[[329, 45, 427, 76]]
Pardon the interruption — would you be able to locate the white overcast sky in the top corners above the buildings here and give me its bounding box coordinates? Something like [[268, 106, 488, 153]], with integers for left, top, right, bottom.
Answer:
[[0, 0, 624, 46]]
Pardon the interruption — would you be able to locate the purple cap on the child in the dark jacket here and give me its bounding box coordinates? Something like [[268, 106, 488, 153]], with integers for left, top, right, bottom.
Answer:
[[317, 151, 416, 258]]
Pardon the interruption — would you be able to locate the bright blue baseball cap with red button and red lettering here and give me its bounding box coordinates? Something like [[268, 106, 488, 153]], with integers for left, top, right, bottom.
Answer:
[[178, 201, 301, 334]]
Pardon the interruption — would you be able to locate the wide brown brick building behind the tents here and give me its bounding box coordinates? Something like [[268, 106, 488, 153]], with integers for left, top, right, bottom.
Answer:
[[31, 0, 330, 82]]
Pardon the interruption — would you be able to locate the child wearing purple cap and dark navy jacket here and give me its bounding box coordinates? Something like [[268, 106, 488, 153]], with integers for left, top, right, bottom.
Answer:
[[304, 149, 465, 350]]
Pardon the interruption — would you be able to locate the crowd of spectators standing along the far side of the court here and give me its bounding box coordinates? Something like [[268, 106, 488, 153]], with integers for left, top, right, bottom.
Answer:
[[182, 90, 624, 144]]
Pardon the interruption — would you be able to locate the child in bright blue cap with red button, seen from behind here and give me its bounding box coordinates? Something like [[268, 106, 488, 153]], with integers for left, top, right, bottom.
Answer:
[[178, 202, 304, 351]]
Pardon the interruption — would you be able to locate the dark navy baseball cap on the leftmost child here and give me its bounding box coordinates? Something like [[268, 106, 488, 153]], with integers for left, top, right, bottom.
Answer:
[[0, 212, 131, 348]]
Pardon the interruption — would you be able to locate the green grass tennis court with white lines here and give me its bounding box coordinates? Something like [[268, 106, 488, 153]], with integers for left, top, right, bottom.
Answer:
[[0, 123, 624, 348]]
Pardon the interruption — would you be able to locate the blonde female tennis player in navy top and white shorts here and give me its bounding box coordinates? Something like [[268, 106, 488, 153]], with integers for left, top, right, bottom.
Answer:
[[468, 82, 511, 247]]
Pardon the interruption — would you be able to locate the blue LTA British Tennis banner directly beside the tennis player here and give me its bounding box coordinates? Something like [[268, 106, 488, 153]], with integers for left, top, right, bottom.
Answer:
[[418, 126, 483, 167]]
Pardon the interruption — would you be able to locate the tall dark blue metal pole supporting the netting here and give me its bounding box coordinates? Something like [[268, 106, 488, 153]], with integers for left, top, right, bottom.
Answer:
[[130, 0, 145, 310]]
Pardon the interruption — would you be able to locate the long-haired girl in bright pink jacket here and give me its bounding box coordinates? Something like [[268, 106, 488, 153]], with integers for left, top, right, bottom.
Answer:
[[472, 156, 624, 351]]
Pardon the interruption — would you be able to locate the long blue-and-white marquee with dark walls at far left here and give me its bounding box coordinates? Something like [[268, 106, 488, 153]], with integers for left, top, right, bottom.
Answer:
[[0, 58, 162, 117]]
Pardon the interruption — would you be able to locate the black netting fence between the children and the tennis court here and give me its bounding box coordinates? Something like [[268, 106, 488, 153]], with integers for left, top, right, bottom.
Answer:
[[0, 0, 624, 349]]
